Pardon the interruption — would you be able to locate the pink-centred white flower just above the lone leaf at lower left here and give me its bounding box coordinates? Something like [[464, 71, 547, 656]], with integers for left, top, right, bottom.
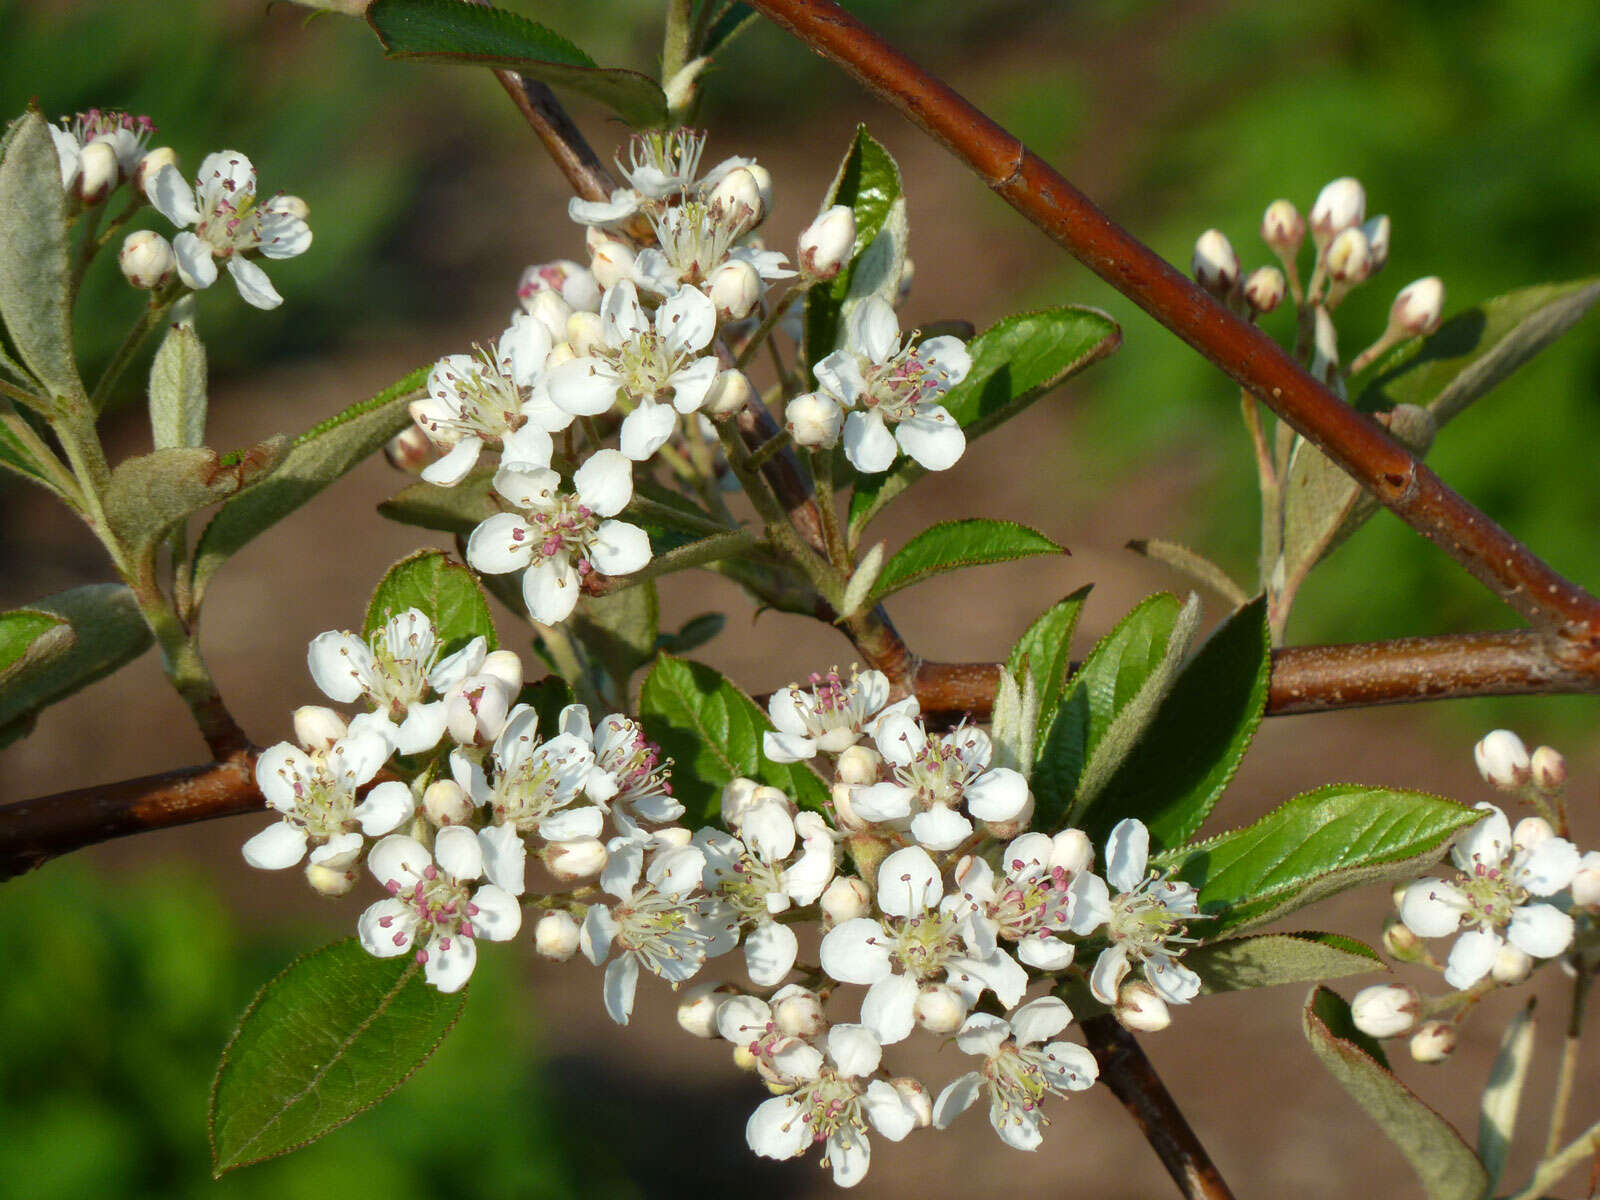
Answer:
[[357, 826, 522, 992]]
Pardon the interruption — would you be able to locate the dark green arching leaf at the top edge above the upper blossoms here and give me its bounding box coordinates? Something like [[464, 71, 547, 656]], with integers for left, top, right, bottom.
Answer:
[[366, 0, 667, 128]]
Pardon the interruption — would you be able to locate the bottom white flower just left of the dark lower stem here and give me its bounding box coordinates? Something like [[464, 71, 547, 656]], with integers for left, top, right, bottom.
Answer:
[[933, 995, 1099, 1150]]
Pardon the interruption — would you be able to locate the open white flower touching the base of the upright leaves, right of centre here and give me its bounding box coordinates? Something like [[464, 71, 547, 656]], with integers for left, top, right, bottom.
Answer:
[[850, 714, 1029, 850]]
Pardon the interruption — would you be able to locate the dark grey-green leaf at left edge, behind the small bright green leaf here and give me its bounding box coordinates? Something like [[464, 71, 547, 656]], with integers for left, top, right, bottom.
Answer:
[[0, 584, 152, 726]]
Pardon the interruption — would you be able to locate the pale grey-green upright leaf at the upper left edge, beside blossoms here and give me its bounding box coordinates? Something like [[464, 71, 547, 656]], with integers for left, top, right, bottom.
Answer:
[[0, 109, 83, 398]]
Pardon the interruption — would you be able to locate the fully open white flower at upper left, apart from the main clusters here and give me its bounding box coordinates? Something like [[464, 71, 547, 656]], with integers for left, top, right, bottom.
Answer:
[[144, 150, 310, 309]]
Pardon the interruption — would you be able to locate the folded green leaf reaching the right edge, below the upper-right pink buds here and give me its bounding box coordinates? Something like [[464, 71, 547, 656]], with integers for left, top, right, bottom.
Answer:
[[1350, 278, 1600, 426]]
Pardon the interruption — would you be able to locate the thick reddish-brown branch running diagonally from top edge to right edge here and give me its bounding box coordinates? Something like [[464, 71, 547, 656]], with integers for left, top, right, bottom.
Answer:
[[752, 0, 1600, 674]]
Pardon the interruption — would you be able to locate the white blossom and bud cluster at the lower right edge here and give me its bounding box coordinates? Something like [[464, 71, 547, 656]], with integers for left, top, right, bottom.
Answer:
[[1352, 730, 1600, 1062]]
